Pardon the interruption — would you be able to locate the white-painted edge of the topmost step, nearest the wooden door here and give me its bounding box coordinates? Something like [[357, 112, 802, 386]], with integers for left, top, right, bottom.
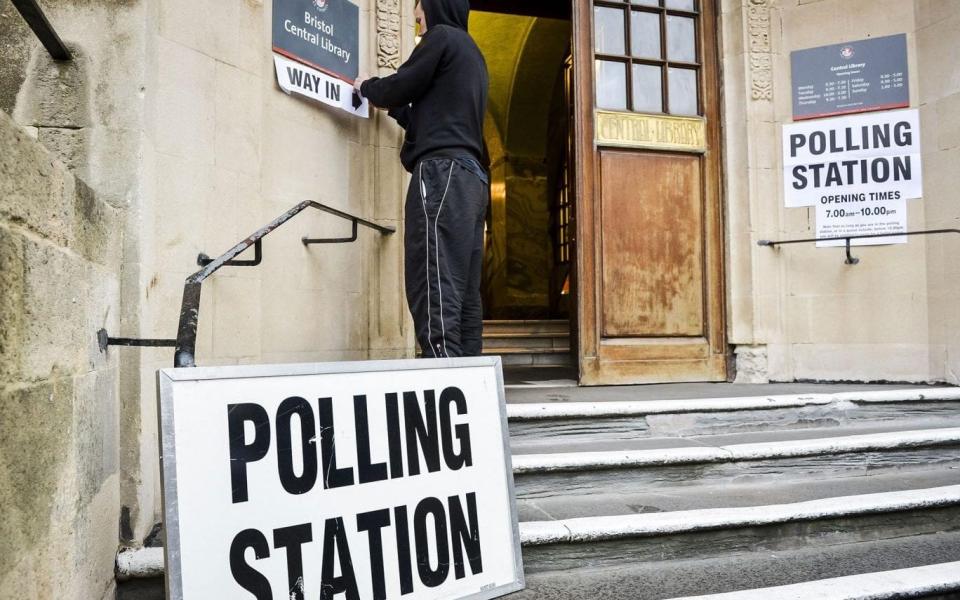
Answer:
[[507, 387, 960, 421]]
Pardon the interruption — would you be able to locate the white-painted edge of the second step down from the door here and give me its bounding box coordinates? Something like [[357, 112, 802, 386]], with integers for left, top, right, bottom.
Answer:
[[512, 427, 960, 474]]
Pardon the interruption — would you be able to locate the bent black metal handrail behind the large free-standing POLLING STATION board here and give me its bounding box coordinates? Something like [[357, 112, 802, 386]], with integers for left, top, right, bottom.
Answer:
[[97, 200, 396, 367]]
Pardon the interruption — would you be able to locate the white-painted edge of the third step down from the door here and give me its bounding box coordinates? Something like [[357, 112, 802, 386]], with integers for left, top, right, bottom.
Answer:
[[520, 485, 960, 546]]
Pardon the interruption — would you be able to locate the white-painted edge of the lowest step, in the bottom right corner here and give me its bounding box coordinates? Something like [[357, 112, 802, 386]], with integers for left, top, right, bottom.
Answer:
[[671, 561, 960, 600]]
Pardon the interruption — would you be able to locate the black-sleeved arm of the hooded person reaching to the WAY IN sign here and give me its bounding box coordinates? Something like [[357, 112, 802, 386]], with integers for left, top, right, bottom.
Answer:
[[360, 28, 446, 109]]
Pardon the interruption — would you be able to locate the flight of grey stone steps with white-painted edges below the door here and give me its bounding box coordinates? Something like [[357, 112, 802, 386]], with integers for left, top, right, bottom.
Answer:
[[508, 389, 960, 600]]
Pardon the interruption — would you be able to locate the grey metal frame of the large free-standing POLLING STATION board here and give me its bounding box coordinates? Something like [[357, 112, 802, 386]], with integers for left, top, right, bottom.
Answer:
[[157, 356, 525, 600]]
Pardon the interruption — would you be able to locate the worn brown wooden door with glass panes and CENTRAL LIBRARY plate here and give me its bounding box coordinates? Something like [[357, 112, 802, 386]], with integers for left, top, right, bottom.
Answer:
[[573, 0, 727, 385]]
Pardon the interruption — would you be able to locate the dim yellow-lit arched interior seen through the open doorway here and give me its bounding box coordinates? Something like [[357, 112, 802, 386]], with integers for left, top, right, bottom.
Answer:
[[470, 10, 572, 320]]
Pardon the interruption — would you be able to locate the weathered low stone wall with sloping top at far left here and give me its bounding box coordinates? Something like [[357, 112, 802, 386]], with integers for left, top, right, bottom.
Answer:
[[0, 111, 123, 600]]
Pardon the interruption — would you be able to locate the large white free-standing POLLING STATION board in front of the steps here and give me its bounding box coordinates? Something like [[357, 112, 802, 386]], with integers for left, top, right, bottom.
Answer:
[[158, 357, 523, 600]]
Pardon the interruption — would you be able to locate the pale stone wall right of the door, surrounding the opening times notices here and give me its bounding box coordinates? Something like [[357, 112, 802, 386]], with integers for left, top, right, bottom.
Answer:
[[720, 0, 960, 381]]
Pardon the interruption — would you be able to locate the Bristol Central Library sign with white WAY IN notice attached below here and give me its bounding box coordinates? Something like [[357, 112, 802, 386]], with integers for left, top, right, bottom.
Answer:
[[272, 0, 369, 117]]
